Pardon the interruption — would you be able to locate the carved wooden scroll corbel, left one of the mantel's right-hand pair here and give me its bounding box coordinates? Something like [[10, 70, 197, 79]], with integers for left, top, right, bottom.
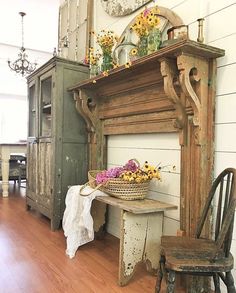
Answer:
[[160, 58, 187, 129]]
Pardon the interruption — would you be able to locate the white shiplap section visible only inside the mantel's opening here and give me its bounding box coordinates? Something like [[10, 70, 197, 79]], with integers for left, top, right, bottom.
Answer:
[[107, 133, 180, 237]]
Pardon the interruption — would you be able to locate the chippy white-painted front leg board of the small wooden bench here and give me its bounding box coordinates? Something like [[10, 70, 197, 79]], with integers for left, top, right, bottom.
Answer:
[[119, 212, 163, 285]]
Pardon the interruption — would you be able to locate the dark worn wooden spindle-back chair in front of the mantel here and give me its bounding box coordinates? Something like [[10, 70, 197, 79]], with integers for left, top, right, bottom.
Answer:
[[155, 168, 236, 293]]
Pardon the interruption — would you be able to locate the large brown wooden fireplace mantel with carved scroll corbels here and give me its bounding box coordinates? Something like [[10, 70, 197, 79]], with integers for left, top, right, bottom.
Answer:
[[69, 40, 224, 235]]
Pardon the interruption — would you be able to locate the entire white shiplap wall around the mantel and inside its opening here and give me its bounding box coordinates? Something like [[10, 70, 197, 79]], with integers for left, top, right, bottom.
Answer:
[[94, 0, 236, 292]]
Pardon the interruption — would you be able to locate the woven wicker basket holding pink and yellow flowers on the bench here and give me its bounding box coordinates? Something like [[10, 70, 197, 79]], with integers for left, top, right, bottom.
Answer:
[[88, 170, 149, 200]]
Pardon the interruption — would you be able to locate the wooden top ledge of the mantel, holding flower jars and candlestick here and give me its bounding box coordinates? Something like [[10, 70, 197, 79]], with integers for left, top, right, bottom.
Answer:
[[68, 40, 225, 91]]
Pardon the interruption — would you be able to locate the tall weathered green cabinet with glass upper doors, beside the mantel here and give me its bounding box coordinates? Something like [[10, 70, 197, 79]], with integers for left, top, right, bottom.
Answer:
[[26, 57, 88, 230]]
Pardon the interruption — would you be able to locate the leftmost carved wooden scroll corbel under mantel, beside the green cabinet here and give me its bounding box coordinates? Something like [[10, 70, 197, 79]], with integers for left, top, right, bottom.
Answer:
[[74, 90, 96, 132]]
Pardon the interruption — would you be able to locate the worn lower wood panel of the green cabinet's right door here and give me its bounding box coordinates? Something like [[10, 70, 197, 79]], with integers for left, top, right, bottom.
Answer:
[[38, 142, 53, 208]]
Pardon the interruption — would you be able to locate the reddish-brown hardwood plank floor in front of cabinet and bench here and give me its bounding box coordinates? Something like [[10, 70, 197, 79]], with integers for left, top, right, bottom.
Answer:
[[0, 184, 181, 293]]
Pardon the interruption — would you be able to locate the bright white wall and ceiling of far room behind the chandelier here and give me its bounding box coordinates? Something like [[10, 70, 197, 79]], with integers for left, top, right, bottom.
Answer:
[[0, 0, 60, 142]]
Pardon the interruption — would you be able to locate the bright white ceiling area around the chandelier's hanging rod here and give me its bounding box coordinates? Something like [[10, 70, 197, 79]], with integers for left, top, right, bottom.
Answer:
[[0, 0, 60, 52]]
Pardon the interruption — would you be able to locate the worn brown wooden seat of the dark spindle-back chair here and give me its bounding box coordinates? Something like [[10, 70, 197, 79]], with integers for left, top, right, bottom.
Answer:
[[161, 236, 234, 273]]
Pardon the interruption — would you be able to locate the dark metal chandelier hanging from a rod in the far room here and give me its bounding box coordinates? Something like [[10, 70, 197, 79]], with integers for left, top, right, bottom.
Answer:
[[7, 12, 37, 76]]
